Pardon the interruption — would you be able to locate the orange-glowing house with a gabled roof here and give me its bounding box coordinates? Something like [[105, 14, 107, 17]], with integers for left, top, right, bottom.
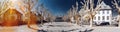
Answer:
[[2, 9, 22, 26]]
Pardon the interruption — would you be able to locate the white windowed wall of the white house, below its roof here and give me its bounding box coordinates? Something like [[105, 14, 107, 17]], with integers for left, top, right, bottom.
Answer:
[[93, 10, 112, 22]]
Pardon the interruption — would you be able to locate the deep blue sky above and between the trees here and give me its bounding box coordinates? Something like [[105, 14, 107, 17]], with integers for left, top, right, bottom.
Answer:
[[39, 0, 117, 16]]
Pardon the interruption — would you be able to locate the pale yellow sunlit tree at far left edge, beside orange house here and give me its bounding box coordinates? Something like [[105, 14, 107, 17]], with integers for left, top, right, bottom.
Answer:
[[0, 0, 11, 23]]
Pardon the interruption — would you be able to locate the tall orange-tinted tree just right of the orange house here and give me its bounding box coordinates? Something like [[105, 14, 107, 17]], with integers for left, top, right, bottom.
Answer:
[[18, 0, 39, 30]]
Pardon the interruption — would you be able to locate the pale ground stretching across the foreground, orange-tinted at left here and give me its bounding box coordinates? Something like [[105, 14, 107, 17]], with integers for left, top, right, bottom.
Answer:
[[0, 22, 120, 32]]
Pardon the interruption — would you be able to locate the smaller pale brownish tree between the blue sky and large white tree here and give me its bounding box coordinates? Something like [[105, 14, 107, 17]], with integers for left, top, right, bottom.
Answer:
[[64, 2, 80, 24]]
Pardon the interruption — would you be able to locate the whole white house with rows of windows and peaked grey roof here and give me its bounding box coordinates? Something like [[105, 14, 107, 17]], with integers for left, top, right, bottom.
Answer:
[[93, 1, 112, 25]]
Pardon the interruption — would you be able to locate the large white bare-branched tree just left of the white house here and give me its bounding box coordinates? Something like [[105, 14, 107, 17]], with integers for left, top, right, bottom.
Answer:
[[80, 0, 101, 26]]
